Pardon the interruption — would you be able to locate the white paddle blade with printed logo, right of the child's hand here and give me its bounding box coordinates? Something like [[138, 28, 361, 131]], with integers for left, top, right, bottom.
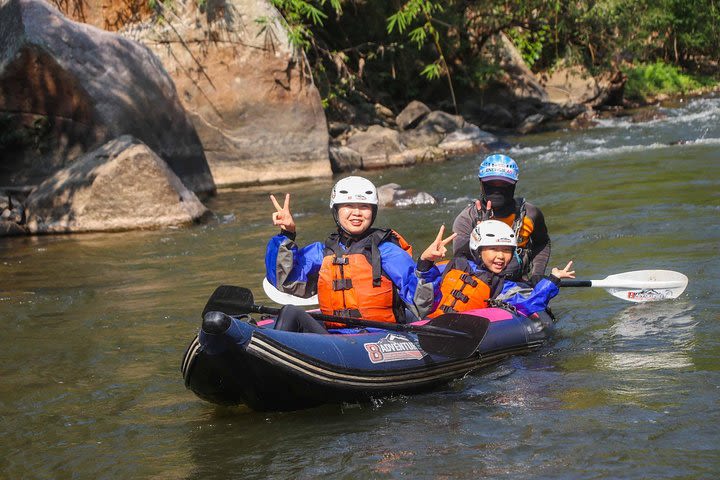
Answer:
[[592, 270, 688, 303]]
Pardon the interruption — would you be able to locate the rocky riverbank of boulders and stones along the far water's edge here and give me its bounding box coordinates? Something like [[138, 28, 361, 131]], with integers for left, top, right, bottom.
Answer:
[[0, 0, 696, 235]]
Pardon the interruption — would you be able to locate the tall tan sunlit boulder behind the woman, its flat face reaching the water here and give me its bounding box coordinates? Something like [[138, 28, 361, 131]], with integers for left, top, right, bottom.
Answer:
[[121, 0, 332, 185]]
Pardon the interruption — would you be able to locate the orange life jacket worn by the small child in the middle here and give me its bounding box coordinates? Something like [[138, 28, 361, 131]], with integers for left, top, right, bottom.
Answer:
[[428, 257, 500, 318]]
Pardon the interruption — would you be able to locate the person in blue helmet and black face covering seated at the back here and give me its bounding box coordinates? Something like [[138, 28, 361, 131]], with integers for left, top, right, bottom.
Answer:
[[453, 154, 550, 285]]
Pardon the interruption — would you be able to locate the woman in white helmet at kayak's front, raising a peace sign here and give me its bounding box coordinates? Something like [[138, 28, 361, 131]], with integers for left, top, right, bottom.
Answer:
[[265, 176, 430, 332]]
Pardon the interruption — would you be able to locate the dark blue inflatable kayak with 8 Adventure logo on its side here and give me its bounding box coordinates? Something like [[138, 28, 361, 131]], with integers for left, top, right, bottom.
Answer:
[[181, 294, 554, 411]]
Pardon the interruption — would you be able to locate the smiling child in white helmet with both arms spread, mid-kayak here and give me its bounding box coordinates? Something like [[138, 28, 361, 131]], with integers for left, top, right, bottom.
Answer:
[[416, 220, 575, 317]]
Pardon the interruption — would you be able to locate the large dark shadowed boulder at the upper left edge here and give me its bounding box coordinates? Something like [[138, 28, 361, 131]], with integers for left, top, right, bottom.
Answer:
[[0, 0, 215, 192]]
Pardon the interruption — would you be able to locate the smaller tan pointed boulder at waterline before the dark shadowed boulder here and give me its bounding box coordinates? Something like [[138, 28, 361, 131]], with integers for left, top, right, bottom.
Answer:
[[25, 136, 209, 233]]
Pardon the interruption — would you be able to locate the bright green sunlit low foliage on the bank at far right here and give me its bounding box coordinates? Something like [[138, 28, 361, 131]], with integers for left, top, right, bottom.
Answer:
[[623, 62, 711, 101]]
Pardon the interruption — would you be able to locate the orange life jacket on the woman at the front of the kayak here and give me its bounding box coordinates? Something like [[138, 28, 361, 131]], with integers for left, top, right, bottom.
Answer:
[[318, 229, 412, 328]]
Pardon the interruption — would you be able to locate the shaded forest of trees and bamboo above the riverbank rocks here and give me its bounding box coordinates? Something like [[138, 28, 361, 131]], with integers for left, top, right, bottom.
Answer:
[[272, 0, 720, 110]]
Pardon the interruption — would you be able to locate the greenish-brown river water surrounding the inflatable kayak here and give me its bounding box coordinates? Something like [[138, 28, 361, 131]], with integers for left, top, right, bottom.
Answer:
[[0, 98, 720, 479]]
